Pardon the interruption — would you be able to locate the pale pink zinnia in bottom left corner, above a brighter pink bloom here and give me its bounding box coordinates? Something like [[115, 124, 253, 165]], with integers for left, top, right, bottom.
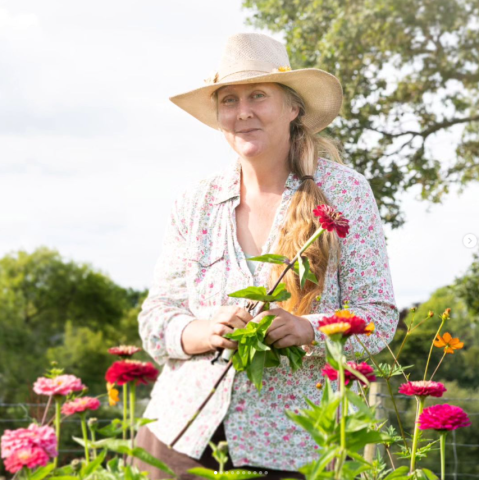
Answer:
[[1, 423, 58, 458]]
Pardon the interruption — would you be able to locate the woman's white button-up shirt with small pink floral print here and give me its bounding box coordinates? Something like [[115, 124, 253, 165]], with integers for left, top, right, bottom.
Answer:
[[138, 158, 399, 471]]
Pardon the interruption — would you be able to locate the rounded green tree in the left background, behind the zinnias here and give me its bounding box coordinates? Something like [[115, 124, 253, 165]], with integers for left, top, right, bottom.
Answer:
[[0, 248, 146, 402]]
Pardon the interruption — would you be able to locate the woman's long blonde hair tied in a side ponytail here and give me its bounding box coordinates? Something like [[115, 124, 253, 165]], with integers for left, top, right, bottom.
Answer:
[[212, 83, 343, 316]]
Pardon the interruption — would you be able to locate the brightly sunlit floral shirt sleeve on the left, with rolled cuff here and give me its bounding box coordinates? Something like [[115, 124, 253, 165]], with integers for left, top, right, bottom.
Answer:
[[138, 189, 195, 365]]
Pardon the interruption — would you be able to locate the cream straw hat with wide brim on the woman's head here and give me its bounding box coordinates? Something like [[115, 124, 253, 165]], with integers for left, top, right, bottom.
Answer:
[[170, 33, 343, 132]]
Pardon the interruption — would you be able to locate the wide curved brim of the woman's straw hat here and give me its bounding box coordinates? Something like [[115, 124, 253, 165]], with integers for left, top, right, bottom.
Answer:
[[170, 68, 343, 133]]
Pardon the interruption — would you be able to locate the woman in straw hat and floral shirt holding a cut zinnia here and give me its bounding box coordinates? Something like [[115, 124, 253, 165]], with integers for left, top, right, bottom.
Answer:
[[133, 33, 398, 479]]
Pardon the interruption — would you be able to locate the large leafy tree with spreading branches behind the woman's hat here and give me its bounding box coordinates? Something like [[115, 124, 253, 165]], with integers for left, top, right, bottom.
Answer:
[[243, 0, 479, 228]]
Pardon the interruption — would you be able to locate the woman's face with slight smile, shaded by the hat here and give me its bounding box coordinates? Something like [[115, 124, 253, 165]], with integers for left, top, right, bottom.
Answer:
[[217, 83, 298, 158]]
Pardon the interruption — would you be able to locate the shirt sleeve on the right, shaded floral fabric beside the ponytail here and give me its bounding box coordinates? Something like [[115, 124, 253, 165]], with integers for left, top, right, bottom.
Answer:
[[303, 176, 399, 356]]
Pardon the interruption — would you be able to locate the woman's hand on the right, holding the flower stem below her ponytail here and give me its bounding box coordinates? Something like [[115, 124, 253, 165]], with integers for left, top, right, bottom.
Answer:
[[253, 308, 314, 348]]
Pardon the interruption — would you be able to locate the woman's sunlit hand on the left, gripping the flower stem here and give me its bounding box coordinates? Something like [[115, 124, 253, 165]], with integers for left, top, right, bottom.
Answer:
[[207, 306, 253, 350]]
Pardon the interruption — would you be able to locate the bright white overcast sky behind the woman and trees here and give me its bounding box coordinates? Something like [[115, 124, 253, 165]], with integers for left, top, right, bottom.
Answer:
[[0, 0, 479, 308]]
